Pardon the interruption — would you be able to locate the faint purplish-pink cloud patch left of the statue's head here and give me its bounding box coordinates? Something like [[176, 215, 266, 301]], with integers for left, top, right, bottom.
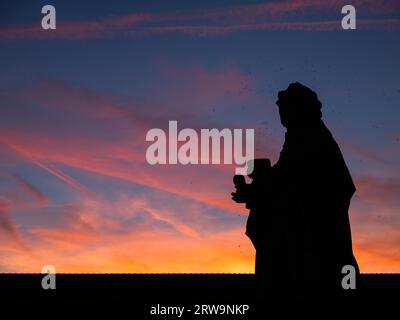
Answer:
[[154, 62, 266, 111]]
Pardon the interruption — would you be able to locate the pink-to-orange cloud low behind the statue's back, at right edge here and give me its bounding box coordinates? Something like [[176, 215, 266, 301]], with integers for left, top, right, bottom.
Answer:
[[350, 176, 400, 273]]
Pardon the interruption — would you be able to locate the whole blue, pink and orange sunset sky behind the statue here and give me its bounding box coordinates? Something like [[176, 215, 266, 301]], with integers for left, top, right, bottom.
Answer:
[[0, 0, 400, 273]]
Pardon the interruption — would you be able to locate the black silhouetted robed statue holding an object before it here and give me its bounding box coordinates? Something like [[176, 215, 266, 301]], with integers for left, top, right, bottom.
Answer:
[[232, 82, 359, 295]]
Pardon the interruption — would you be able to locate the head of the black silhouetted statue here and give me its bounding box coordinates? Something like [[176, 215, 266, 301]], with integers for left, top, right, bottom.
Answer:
[[276, 82, 322, 128]]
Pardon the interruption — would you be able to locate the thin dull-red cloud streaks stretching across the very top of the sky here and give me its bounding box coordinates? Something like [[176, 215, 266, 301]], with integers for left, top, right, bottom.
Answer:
[[0, 0, 400, 40]]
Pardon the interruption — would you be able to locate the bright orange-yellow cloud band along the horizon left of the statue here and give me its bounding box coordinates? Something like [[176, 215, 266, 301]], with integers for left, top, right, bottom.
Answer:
[[14, 226, 254, 273]]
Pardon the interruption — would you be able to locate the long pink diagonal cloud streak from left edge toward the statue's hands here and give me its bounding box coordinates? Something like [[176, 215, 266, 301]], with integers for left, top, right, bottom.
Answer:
[[3, 132, 241, 211]]
